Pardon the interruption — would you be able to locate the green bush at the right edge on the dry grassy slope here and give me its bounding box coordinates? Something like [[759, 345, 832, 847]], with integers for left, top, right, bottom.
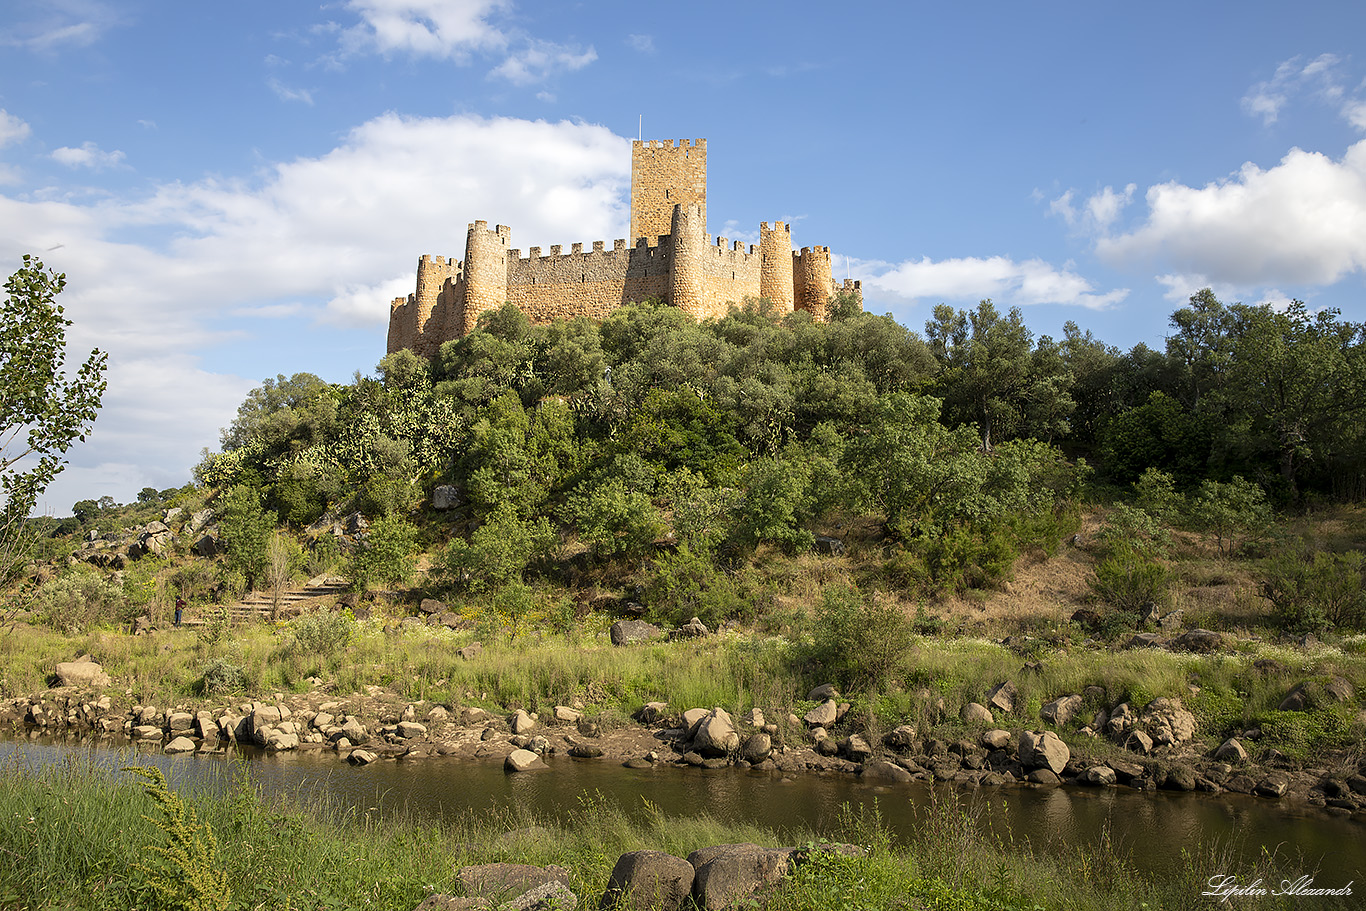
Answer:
[[1262, 550, 1366, 632]]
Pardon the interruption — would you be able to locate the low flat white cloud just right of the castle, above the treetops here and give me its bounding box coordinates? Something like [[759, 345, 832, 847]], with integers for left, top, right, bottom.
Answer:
[[855, 257, 1128, 310]]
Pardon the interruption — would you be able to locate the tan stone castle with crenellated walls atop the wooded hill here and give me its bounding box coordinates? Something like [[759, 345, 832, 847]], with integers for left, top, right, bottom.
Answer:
[[388, 139, 861, 358]]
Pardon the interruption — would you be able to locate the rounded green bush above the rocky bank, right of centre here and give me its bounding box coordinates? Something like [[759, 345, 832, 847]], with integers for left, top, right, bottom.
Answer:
[[807, 586, 914, 691]]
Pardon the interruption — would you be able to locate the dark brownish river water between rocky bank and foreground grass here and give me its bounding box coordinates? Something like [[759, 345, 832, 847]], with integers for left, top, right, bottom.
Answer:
[[0, 740, 1366, 885]]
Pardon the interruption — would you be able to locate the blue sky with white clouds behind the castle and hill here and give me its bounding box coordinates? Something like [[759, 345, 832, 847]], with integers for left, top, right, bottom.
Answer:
[[0, 0, 1366, 515]]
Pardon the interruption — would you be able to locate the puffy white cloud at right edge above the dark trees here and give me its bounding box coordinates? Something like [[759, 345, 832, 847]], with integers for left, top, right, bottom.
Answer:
[[1096, 141, 1366, 285]]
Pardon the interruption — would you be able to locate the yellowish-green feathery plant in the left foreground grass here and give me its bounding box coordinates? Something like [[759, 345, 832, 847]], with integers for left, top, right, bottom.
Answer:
[[124, 766, 232, 911]]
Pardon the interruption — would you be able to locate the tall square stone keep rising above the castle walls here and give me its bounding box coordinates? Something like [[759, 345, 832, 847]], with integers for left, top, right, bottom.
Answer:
[[631, 139, 706, 243]]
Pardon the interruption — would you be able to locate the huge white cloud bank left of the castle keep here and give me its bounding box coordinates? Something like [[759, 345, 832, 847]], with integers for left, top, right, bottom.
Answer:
[[0, 113, 630, 512]]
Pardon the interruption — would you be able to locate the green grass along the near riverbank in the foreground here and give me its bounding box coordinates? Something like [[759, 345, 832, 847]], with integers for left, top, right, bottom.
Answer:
[[0, 762, 1346, 911]]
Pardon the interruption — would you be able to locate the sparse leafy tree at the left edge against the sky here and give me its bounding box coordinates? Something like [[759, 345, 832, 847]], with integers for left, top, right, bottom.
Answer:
[[0, 254, 107, 611]]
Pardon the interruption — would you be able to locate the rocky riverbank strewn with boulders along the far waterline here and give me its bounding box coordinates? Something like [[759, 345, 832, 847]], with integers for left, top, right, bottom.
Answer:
[[10, 660, 1366, 821]]
